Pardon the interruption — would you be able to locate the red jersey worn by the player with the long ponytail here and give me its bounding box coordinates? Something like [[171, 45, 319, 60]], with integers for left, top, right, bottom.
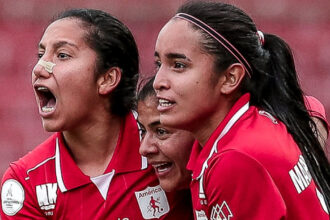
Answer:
[[188, 94, 329, 220]]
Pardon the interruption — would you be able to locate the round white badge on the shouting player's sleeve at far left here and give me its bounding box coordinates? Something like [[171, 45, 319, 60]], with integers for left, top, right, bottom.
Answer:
[[1, 179, 25, 216]]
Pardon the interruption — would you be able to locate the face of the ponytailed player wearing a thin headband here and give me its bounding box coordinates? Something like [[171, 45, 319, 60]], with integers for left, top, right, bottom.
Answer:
[[154, 19, 226, 141]]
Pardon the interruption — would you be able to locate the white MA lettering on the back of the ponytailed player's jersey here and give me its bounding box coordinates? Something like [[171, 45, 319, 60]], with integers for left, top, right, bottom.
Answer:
[[289, 155, 312, 194]]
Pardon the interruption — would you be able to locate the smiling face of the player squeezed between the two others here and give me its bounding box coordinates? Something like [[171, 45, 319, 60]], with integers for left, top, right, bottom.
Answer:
[[138, 96, 194, 192]]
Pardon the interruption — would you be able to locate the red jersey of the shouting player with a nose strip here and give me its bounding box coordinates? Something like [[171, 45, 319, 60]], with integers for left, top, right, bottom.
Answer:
[[1, 114, 191, 220]]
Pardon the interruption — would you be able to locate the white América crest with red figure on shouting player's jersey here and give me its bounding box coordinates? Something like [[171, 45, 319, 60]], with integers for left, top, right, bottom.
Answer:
[[135, 185, 170, 219]]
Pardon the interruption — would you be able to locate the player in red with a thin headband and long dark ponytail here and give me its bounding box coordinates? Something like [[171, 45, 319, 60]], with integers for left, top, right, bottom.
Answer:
[[154, 1, 330, 219]]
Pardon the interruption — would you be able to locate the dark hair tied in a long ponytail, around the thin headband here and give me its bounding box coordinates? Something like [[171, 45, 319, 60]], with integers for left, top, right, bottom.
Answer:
[[177, 1, 330, 210]]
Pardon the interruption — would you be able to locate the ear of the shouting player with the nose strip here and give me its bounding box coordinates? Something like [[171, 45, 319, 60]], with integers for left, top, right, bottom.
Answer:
[[97, 67, 122, 95]]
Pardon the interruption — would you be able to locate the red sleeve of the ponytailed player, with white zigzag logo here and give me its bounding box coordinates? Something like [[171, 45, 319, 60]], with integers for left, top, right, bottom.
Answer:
[[204, 150, 286, 220]]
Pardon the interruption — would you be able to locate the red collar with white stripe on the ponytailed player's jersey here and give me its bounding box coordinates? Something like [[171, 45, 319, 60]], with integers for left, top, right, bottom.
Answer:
[[187, 93, 250, 179]]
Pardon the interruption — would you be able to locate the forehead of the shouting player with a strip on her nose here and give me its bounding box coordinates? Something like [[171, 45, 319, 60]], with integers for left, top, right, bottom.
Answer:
[[40, 18, 86, 45]]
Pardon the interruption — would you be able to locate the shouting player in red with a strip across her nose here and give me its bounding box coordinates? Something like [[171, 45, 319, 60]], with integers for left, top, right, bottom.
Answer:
[[1, 9, 181, 220]]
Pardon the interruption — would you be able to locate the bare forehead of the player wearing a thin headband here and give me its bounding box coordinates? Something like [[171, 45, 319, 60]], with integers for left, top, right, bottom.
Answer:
[[155, 18, 201, 53]]
